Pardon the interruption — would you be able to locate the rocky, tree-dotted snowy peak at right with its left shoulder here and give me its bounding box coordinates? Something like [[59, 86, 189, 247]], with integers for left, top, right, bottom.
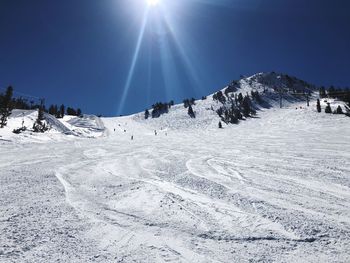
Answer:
[[133, 72, 316, 130]]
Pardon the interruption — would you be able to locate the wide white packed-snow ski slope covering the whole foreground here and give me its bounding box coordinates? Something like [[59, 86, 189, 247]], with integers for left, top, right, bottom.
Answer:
[[0, 99, 350, 262]]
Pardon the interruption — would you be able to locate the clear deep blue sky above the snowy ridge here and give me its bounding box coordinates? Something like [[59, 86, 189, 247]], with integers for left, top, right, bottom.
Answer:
[[0, 0, 350, 116]]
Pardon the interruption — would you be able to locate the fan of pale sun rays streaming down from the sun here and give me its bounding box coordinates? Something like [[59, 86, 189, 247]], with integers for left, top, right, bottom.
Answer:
[[117, 0, 216, 115]]
